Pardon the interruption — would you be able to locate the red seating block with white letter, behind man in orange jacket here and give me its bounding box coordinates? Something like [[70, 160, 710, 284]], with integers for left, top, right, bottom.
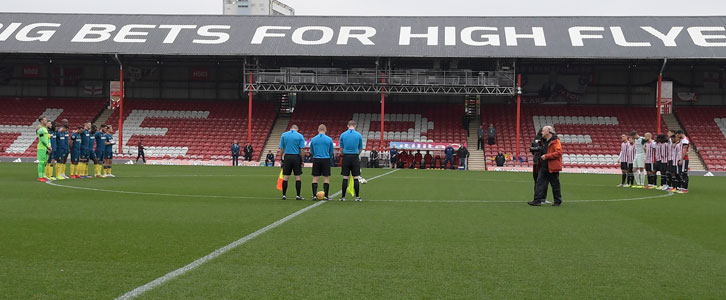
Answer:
[[483, 105, 666, 169]]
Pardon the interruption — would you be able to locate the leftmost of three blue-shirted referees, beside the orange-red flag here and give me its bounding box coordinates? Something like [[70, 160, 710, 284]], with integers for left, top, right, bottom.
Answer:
[[280, 125, 305, 200]]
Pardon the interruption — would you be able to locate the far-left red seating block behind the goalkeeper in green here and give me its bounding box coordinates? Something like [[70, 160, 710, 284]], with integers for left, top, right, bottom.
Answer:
[[0, 98, 106, 157]]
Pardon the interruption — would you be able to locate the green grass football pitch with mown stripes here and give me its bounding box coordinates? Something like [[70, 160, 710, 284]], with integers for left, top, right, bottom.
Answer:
[[0, 164, 726, 299]]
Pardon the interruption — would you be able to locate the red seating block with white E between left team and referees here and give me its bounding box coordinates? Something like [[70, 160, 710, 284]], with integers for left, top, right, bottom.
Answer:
[[107, 99, 276, 162]]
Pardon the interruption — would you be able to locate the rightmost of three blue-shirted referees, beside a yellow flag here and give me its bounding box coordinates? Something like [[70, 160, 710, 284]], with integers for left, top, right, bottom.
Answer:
[[340, 120, 363, 202]]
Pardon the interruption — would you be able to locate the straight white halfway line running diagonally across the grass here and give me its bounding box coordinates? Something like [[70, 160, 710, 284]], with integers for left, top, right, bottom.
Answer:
[[116, 169, 398, 300]]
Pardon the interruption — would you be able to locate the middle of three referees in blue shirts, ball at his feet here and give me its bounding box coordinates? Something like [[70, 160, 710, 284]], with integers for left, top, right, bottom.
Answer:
[[310, 124, 335, 201]]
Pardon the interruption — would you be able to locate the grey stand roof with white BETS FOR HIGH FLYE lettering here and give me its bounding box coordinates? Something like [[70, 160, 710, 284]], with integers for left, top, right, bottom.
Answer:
[[0, 13, 726, 59]]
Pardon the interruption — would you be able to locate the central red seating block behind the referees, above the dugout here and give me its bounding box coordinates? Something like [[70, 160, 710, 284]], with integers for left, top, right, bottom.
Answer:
[[288, 101, 466, 150]]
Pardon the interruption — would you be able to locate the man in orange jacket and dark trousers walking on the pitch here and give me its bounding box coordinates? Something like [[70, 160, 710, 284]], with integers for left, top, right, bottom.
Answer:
[[528, 126, 562, 206]]
